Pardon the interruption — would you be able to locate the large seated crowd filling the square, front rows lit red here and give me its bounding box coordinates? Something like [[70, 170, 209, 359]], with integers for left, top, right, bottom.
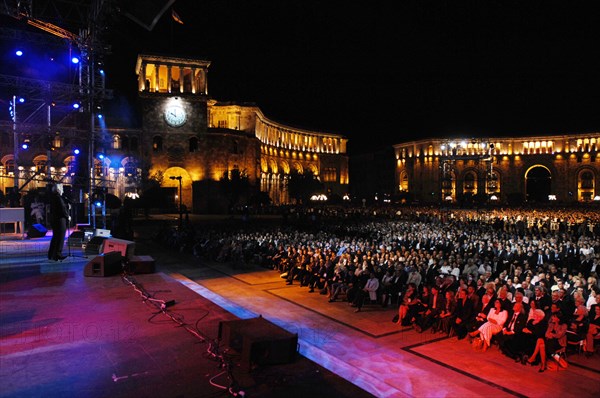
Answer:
[[156, 207, 600, 371]]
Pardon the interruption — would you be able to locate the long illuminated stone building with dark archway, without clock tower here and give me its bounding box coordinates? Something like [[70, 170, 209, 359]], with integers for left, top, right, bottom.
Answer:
[[393, 133, 600, 204]]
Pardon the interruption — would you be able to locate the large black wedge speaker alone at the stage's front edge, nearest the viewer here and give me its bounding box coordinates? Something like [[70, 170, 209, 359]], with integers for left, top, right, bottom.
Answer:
[[219, 316, 298, 370]]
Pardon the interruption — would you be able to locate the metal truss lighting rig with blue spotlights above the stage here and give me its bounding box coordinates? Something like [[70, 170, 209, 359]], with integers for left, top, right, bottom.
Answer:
[[0, 0, 112, 227]]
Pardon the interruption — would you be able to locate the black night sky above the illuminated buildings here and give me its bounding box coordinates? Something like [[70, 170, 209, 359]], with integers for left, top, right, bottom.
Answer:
[[4, 0, 600, 153]]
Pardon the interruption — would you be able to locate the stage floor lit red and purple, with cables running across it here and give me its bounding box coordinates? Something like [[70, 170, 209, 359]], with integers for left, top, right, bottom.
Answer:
[[0, 252, 370, 397]]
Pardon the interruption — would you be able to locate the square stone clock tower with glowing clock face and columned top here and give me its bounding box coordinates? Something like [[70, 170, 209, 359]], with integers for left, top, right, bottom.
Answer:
[[135, 54, 210, 210]]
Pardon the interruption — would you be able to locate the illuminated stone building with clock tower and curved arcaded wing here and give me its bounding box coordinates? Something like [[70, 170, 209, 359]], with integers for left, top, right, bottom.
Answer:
[[0, 55, 349, 213]]
